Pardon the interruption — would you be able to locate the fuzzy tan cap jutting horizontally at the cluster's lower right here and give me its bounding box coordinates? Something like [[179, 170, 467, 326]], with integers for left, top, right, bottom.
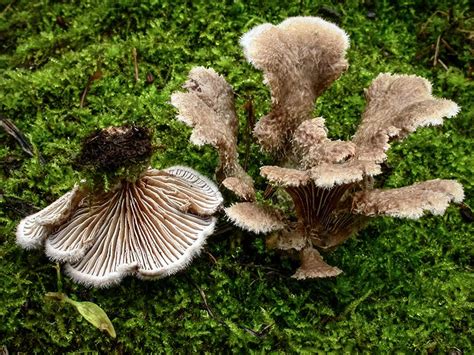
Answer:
[[353, 179, 464, 219]]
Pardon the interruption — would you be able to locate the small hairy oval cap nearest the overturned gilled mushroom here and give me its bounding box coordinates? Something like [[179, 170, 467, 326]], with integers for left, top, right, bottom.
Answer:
[[224, 202, 285, 233]]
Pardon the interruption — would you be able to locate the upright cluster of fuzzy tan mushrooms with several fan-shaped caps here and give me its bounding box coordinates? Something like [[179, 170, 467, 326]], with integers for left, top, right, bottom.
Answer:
[[172, 17, 464, 279]]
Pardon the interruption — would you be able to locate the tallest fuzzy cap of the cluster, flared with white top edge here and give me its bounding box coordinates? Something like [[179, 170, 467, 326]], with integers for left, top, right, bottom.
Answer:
[[240, 17, 349, 152]]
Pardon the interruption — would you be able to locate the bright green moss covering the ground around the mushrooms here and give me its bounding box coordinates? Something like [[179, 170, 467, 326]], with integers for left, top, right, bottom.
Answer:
[[0, 0, 474, 354]]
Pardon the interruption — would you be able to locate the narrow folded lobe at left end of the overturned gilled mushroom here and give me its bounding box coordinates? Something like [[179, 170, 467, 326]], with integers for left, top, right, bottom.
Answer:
[[16, 185, 85, 249]]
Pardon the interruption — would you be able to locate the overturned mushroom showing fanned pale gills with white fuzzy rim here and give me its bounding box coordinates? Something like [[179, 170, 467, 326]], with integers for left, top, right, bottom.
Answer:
[[17, 166, 222, 287]]
